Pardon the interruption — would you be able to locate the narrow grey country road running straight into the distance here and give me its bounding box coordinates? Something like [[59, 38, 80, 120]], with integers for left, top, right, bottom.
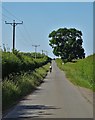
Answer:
[[4, 61, 93, 118]]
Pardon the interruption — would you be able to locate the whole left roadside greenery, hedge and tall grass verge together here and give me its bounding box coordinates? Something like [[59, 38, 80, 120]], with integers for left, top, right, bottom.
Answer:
[[2, 51, 50, 111]]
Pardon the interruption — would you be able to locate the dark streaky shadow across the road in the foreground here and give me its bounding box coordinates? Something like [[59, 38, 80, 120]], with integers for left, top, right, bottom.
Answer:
[[11, 105, 60, 118]]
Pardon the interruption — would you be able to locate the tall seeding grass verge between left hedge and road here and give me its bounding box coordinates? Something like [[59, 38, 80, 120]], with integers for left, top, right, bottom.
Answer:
[[2, 63, 49, 112]]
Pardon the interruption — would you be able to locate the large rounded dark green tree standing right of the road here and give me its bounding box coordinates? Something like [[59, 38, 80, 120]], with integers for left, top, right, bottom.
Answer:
[[49, 28, 85, 62]]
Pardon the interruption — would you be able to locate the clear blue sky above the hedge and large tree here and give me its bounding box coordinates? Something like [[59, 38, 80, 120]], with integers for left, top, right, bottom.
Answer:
[[0, 2, 93, 57]]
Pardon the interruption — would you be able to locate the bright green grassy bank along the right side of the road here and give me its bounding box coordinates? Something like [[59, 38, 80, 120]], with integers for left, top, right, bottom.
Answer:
[[56, 54, 95, 91]]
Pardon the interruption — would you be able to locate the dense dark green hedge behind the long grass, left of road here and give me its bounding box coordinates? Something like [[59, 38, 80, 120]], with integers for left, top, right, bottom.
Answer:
[[2, 52, 49, 78]]
